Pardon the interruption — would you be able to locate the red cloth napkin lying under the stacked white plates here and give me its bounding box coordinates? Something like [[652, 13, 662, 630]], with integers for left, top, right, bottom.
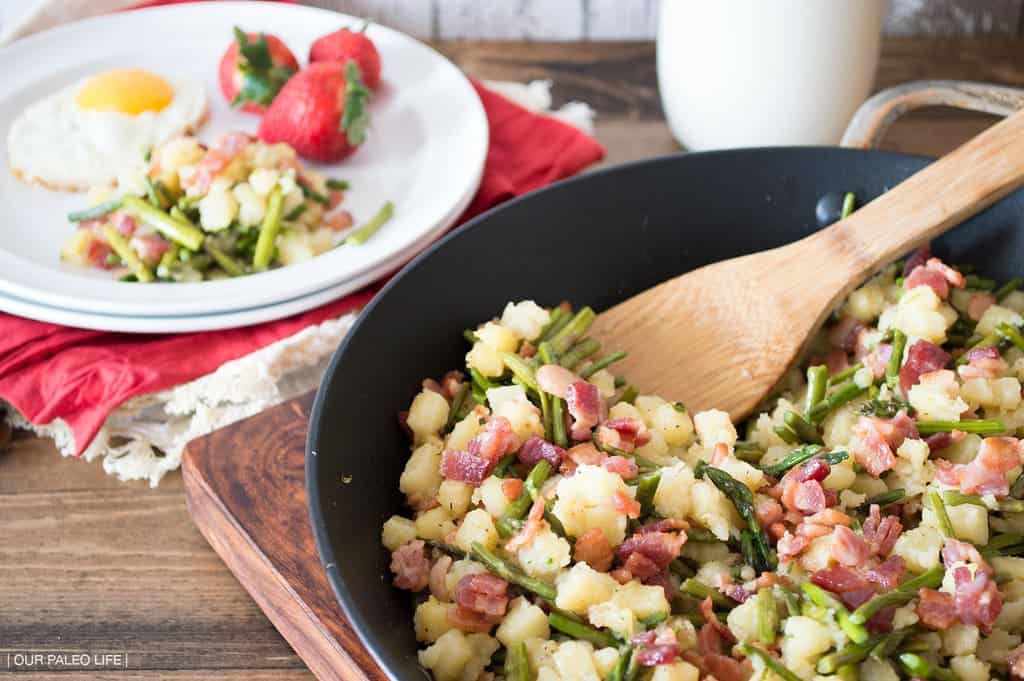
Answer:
[[0, 82, 604, 455]]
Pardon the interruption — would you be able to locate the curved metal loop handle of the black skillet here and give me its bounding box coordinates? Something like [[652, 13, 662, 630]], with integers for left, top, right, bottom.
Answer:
[[840, 80, 1024, 148]]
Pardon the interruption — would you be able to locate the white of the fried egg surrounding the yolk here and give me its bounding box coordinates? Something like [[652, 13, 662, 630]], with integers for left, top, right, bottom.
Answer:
[[7, 76, 207, 190]]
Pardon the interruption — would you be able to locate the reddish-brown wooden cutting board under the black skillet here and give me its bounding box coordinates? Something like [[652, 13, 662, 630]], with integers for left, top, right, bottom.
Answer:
[[181, 393, 387, 681]]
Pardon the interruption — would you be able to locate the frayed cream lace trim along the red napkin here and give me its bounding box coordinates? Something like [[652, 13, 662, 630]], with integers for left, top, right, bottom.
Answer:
[[4, 81, 594, 487]]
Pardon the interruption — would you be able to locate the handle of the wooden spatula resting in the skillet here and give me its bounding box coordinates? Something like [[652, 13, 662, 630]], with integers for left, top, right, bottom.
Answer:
[[799, 111, 1024, 282]]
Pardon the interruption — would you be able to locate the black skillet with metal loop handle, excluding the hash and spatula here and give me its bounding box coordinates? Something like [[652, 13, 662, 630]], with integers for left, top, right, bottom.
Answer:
[[306, 78, 1024, 679]]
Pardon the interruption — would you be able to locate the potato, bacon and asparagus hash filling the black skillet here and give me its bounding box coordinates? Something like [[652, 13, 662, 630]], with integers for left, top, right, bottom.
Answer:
[[382, 241, 1024, 681]]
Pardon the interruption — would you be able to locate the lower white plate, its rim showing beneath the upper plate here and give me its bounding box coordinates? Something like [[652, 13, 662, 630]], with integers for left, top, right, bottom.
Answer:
[[0, 166, 474, 334]]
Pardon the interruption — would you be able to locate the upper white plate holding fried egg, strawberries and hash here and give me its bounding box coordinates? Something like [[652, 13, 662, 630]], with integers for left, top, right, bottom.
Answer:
[[0, 2, 487, 317]]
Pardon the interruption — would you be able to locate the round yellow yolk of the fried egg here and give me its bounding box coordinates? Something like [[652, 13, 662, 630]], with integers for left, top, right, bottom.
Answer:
[[75, 69, 174, 116]]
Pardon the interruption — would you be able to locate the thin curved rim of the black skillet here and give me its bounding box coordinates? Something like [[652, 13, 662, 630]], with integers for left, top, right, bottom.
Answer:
[[305, 145, 932, 681]]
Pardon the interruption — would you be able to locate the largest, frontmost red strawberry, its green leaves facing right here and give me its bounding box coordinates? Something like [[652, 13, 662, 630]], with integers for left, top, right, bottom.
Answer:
[[259, 61, 370, 163]]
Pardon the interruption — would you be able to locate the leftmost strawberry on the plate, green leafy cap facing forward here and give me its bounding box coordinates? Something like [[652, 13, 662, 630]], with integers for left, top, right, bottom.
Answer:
[[218, 27, 299, 114]]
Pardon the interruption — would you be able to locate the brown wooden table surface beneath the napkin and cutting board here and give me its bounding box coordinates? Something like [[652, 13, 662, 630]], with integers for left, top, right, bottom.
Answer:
[[0, 39, 1024, 681]]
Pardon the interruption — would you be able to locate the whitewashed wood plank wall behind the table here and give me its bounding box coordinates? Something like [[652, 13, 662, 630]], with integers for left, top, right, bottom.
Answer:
[[306, 0, 1024, 40]]
